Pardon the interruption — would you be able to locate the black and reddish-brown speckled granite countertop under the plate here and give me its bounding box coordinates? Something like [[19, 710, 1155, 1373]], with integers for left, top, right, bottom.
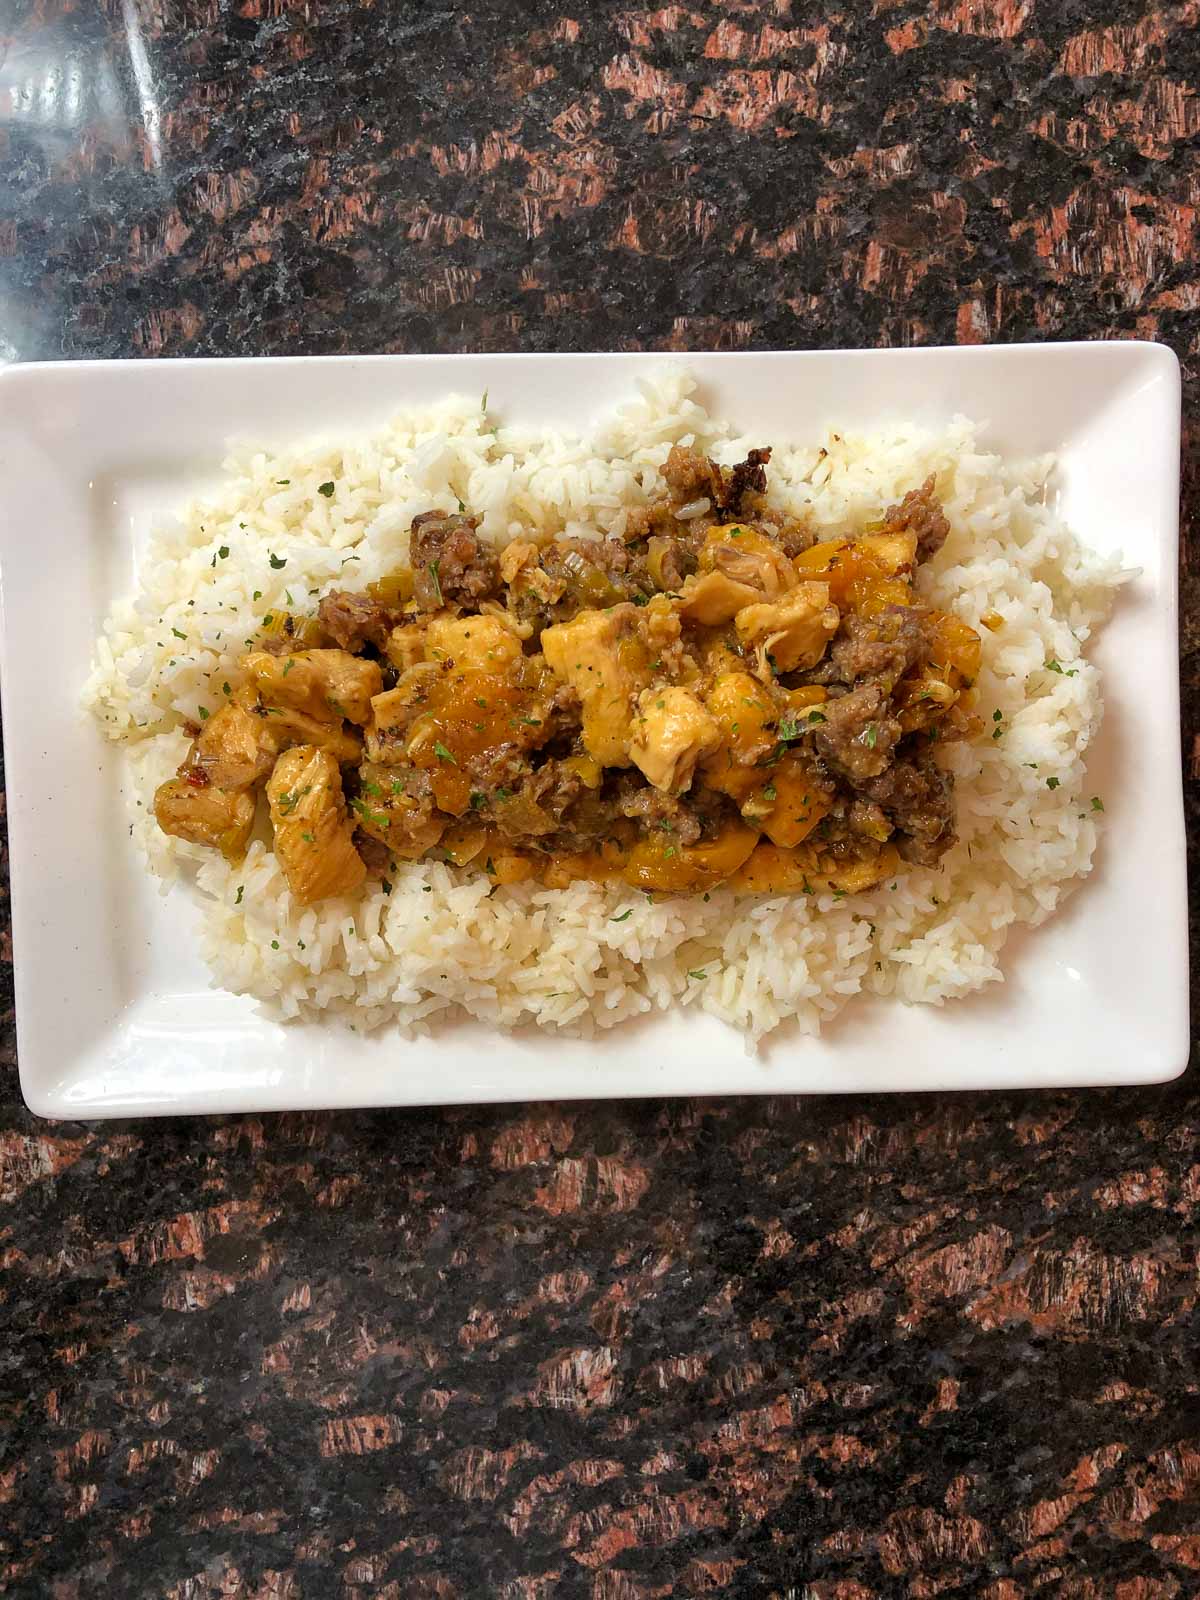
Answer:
[[0, 0, 1200, 1600]]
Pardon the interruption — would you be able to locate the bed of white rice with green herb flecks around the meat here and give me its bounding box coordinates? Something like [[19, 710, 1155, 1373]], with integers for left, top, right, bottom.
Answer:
[[85, 370, 1123, 1040]]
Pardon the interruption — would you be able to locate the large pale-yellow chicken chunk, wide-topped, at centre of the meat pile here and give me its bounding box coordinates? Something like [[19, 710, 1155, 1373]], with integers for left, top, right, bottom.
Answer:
[[541, 605, 659, 766]]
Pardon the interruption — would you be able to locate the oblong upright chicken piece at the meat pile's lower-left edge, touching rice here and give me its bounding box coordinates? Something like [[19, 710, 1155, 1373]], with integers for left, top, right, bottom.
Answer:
[[267, 744, 366, 906]]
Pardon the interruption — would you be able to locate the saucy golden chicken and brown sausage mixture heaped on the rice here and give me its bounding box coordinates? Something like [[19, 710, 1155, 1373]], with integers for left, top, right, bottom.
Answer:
[[155, 445, 981, 904]]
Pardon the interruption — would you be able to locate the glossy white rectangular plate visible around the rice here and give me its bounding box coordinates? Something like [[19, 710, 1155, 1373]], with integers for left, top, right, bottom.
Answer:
[[0, 342, 1187, 1117]]
